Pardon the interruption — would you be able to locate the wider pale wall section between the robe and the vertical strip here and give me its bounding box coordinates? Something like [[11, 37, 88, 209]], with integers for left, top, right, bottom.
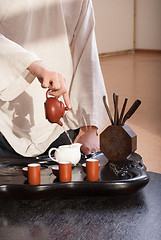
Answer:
[[93, 0, 134, 53]]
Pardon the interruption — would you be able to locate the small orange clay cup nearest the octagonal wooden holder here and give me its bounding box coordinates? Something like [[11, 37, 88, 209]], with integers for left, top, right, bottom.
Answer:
[[86, 158, 100, 181]]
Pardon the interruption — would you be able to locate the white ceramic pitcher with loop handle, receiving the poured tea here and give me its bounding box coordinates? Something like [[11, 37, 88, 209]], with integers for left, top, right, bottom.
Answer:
[[48, 143, 82, 165]]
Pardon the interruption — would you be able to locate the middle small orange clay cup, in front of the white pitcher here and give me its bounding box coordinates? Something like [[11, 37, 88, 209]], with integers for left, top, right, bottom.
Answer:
[[59, 161, 72, 182]]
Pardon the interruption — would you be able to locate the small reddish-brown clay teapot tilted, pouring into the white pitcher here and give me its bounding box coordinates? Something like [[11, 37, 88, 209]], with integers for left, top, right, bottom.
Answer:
[[44, 89, 68, 126]]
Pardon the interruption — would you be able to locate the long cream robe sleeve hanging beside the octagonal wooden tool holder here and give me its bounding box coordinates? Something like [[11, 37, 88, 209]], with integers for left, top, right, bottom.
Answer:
[[63, 0, 108, 133]]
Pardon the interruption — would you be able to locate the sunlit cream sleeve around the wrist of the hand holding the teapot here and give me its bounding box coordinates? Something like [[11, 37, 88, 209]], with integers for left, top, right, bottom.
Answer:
[[0, 34, 39, 101]]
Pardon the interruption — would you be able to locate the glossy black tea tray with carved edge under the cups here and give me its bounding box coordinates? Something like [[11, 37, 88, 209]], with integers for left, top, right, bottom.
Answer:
[[0, 152, 149, 199]]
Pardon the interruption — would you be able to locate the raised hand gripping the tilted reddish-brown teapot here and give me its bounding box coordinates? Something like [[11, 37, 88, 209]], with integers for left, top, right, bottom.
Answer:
[[27, 61, 70, 108]]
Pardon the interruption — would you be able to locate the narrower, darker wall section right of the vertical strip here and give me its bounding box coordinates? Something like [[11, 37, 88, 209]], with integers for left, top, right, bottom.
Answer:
[[136, 0, 161, 50]]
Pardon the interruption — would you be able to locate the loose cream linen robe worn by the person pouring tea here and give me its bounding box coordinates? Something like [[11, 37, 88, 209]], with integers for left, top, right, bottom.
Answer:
[[0, 0, 107, 156]]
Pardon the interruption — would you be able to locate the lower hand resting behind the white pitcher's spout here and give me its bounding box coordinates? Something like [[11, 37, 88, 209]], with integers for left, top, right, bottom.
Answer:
[[74, 126, 100, 155]]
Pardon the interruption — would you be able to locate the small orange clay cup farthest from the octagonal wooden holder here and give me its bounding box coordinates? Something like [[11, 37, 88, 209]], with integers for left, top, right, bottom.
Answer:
[[28, 163, 40, 185]]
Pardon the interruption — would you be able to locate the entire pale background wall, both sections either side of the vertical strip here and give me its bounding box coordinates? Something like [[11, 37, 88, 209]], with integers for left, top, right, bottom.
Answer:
[[93, 0, 161, 53]]
